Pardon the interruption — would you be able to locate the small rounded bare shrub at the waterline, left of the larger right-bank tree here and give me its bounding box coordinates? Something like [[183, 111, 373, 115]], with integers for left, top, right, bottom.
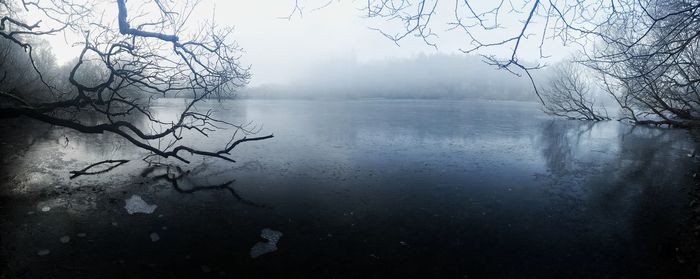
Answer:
[[542, 62, 610, 121]]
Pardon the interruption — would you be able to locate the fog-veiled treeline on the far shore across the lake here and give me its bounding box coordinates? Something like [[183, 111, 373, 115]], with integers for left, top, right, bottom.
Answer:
[[237, 54, 537, 101]]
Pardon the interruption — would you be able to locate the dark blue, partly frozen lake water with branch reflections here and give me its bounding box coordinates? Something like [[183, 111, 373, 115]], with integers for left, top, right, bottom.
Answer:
[[0, 100, 695, 278]]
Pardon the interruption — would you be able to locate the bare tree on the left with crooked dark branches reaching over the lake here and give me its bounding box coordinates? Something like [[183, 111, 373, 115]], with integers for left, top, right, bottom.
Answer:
[[0, 0, 272, 166]]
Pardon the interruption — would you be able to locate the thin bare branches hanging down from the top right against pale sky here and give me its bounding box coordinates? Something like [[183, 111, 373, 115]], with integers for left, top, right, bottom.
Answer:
[[290, 0, 700, 122]]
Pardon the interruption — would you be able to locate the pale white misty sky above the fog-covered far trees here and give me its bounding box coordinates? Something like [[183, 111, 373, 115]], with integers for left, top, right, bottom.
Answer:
[[45, 0, 566, 86]]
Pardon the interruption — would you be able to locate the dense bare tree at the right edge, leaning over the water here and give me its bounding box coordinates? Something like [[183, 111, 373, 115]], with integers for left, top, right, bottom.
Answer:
[[586, 1, 700, 127]]
